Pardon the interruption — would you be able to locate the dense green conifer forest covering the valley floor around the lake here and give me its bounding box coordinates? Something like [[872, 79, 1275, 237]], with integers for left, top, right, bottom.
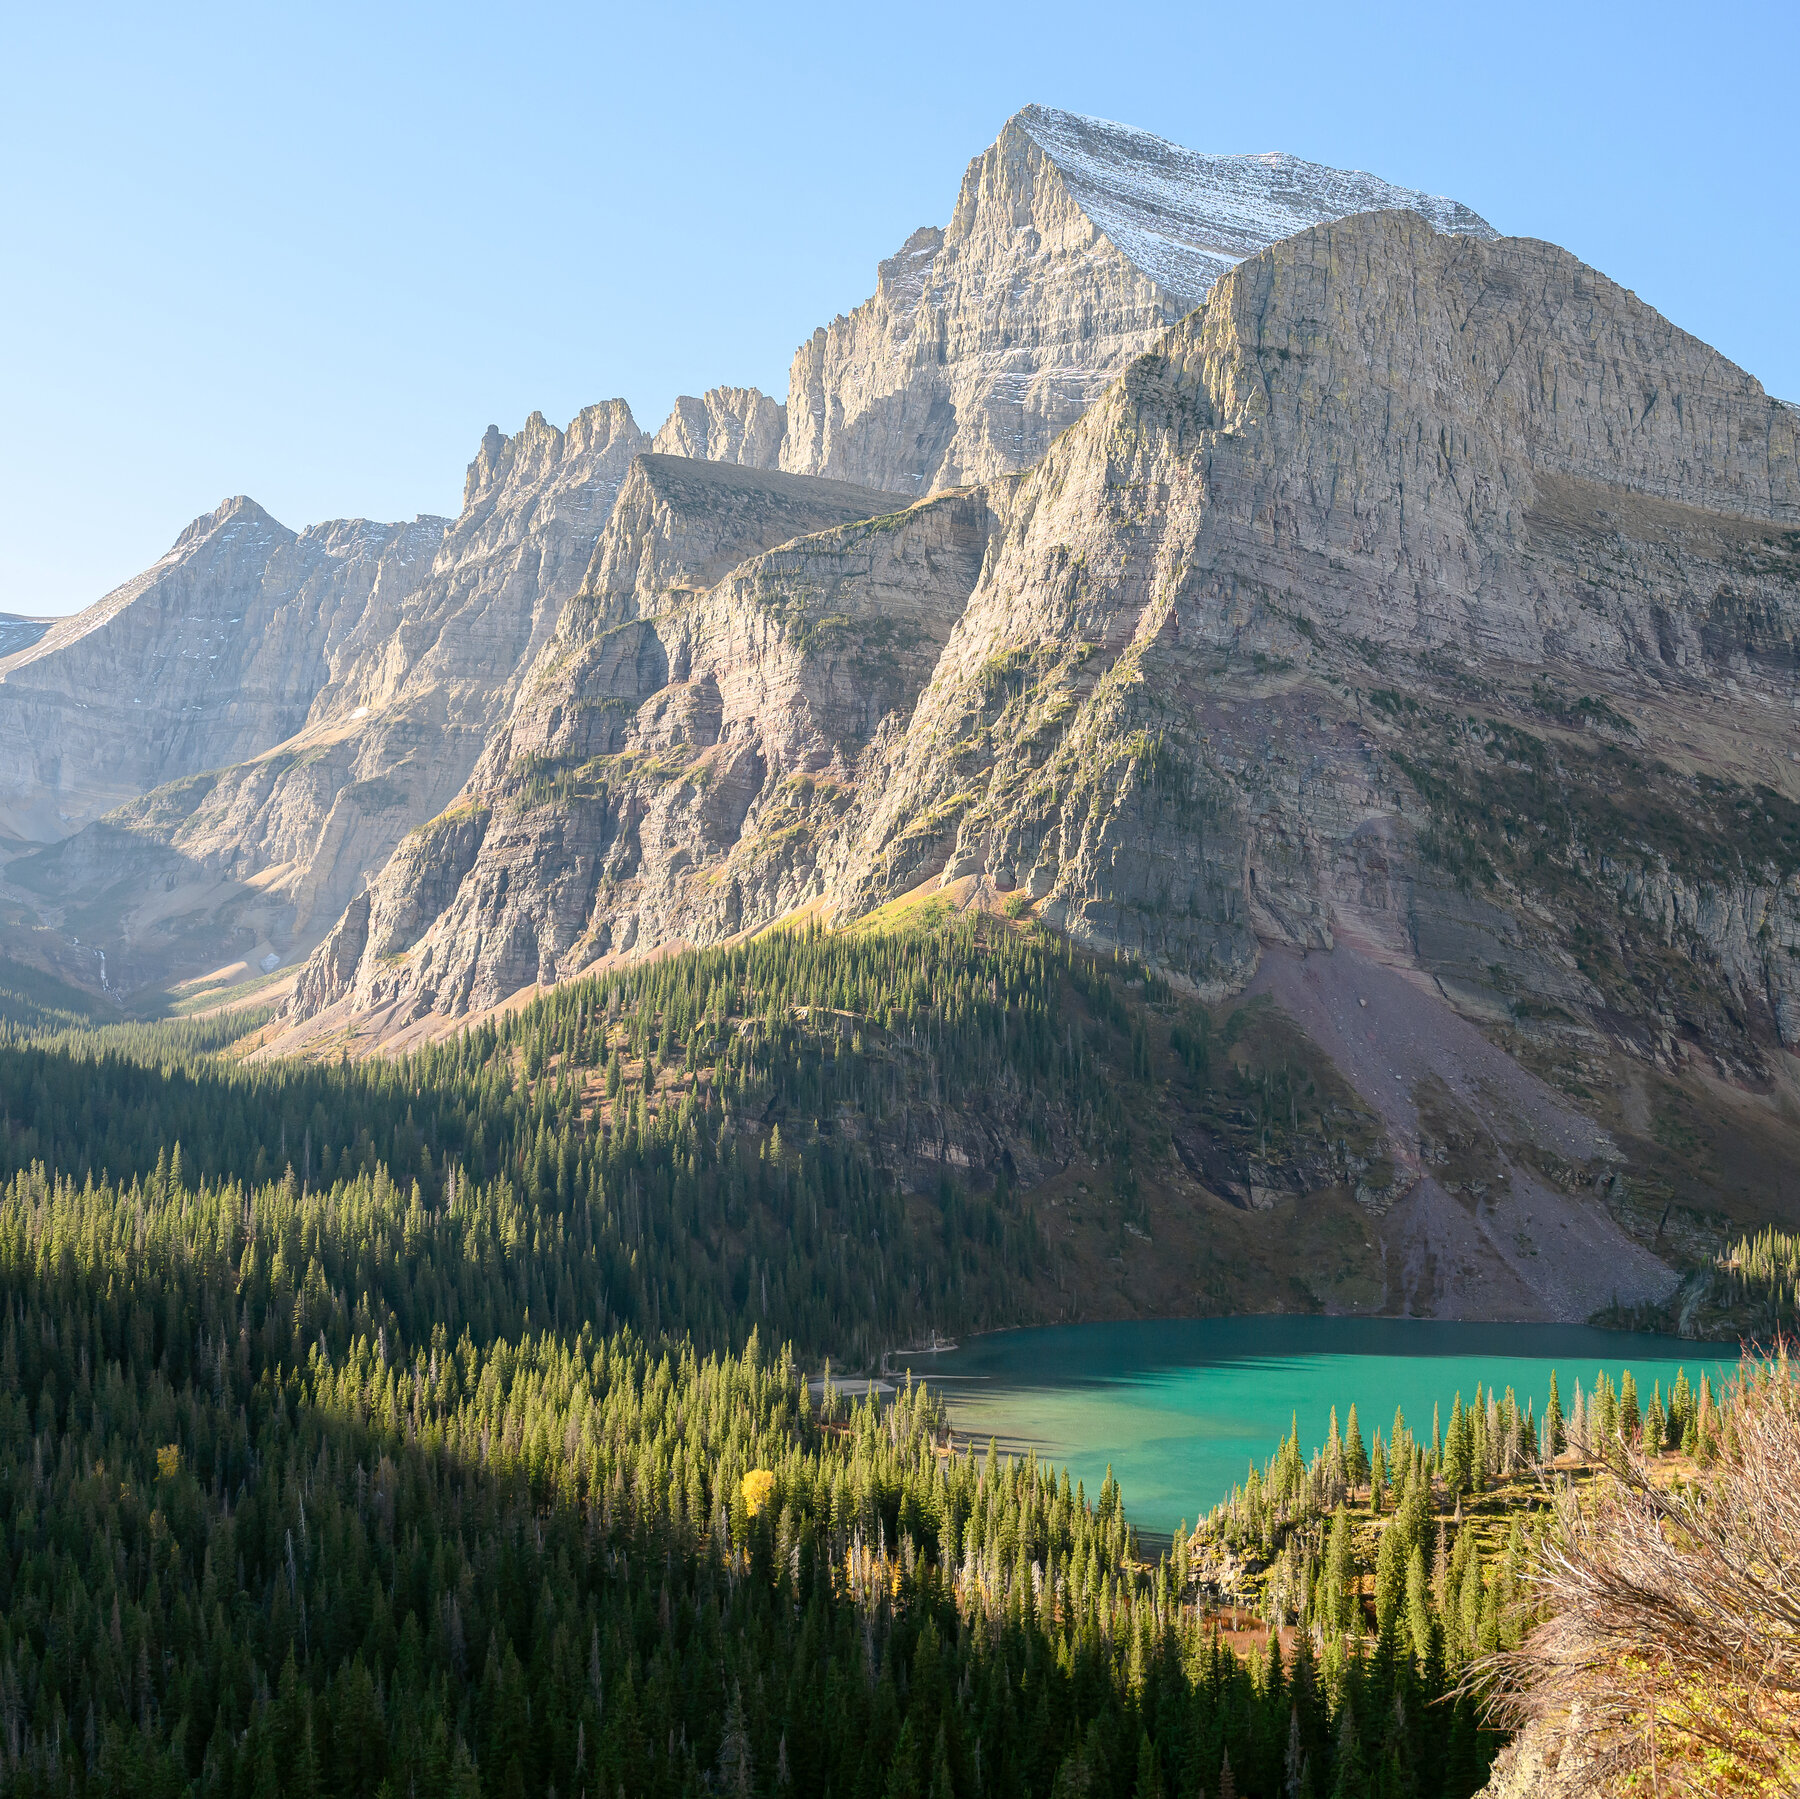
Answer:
[[0, 922, 1771, 1799]]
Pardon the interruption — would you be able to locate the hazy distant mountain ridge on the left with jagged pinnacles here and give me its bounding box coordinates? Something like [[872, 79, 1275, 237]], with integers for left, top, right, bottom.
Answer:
[[0, 400, 648, 992]]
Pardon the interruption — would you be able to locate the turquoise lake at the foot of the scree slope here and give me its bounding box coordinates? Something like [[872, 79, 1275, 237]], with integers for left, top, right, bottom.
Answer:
[[891, 1318, 1737, 1532]]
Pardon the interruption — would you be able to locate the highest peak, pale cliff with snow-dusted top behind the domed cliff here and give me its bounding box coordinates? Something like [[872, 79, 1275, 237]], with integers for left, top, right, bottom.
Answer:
[[781, 106, 1492, 493]]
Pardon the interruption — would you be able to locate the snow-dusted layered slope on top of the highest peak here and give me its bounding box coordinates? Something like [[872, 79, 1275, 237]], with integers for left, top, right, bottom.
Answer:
[[1013, 106, 1498, 306]]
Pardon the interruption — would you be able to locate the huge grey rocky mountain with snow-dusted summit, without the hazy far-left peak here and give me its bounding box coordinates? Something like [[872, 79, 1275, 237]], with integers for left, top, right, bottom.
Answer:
[[0, 108, 1800, 1318]]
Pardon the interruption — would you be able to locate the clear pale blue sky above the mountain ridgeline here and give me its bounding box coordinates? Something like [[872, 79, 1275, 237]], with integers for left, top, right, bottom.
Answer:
[[0, 0, 1800, 612]]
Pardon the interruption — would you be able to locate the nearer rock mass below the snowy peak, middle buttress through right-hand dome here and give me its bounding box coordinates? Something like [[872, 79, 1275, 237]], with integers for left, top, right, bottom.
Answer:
[[290, 200, 1800, 1316]]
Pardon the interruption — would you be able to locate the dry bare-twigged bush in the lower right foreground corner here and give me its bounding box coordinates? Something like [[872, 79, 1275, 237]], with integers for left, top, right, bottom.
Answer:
[[1487, 1354, 1800, 1799]]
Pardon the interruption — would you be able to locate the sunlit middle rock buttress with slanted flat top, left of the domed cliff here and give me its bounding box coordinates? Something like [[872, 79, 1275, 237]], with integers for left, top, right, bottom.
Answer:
[[297, 456, 986, 1021]]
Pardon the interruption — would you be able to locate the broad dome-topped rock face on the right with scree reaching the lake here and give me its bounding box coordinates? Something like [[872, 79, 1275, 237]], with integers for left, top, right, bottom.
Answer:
[[810, 214, 1800, 1316]]
